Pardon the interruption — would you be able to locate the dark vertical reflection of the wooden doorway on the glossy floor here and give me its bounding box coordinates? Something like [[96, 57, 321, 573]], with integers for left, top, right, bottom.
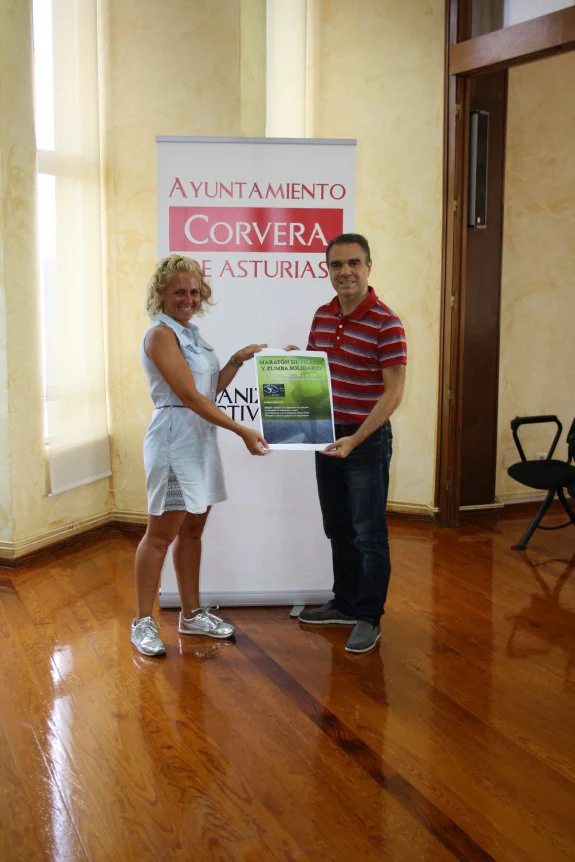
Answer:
[[429, 531, 497, 859]]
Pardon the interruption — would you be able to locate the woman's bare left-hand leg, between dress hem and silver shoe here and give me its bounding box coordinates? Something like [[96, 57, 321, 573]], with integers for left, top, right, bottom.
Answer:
[[135, 511, 187, 619]]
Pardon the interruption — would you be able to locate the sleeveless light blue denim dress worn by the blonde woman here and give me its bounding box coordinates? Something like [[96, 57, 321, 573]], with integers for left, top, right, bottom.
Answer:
[[140, 314, 226, 515]]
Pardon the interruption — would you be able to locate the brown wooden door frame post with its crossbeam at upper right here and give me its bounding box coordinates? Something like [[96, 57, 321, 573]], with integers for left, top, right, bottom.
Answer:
[[435, 0, 575, 527]]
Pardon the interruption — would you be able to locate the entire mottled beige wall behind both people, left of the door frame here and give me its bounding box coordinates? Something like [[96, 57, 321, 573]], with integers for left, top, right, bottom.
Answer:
[[0, 0, 443, 556]]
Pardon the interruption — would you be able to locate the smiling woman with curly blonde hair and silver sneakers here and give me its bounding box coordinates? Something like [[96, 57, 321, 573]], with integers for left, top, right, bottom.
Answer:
[[131, 255, 269, 656]]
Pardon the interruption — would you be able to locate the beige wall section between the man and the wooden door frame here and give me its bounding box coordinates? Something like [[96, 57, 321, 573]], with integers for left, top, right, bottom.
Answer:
[[311, 0, 444, 506]]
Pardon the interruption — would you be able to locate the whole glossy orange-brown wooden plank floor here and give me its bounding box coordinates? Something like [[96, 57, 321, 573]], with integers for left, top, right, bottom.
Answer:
[[0, 519, 575, 862]]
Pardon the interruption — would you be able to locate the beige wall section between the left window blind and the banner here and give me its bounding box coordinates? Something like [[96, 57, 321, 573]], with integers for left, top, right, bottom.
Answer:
[[105, 0, 245, 517]]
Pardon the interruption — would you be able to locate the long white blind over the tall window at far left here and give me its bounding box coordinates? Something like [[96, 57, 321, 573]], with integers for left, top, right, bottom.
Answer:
[[33, 0, 111, 494]]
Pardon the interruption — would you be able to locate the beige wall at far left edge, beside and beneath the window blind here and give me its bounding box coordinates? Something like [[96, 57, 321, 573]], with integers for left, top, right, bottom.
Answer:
[[0, 0, 108, 557]]
